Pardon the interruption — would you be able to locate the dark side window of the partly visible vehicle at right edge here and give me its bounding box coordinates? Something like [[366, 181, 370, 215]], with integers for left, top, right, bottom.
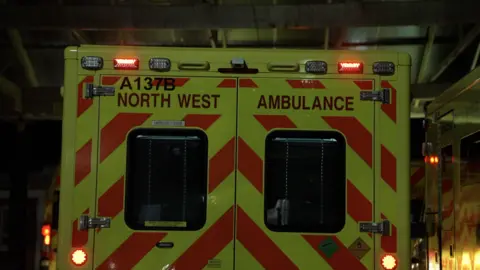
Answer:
[[460, 131, 480, 186]]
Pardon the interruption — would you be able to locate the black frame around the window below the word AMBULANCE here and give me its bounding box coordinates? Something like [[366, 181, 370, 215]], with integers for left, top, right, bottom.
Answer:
[[263, 129, 348, 234]]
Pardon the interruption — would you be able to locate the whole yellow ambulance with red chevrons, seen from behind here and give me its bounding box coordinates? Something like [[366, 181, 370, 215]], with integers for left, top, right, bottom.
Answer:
[[56, 45, 411, 270]]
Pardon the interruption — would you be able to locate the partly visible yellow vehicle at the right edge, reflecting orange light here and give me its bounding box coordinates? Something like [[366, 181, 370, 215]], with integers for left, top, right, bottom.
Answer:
[[424, 68, 480, 270]]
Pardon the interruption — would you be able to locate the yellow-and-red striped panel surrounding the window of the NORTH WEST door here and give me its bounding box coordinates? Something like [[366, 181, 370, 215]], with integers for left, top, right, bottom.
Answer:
[[94, 74, 236, 269]]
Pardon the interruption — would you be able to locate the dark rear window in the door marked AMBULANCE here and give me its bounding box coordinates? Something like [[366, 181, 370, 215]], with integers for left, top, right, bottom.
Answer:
[[264, 131, 346, 233]]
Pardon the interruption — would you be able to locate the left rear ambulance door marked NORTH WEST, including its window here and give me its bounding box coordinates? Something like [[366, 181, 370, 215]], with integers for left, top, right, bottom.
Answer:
[[92, 71, 236, 270]]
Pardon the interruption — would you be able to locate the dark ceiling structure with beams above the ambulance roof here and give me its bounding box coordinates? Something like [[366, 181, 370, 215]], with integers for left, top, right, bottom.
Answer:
[[0, 0, 480, 119]]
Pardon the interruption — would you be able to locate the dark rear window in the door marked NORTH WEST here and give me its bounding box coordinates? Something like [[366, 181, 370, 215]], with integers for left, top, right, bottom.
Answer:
[[125, 129, 208, 230]]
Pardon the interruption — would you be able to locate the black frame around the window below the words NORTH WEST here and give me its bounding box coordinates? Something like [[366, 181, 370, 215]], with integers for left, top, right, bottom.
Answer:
[[124, 127, 209, 231]]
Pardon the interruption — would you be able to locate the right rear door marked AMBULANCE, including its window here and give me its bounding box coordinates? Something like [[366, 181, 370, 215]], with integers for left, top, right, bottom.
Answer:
[[235, 75, 379, 270]]
